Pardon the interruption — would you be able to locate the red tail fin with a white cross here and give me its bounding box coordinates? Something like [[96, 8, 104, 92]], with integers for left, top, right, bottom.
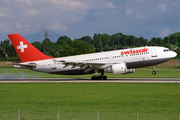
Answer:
[[8, 34, 52, 62]]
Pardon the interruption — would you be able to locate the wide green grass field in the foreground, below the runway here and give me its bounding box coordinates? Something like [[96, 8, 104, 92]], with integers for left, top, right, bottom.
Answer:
[[0, 83, 180, 120]]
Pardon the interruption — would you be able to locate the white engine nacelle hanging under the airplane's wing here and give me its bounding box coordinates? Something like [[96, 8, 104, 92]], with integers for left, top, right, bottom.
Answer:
[[104, 63, 135, 74]]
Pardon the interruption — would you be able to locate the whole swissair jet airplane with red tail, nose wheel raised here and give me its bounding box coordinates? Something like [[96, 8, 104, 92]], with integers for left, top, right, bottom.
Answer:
[[8, 34, 177, 80]]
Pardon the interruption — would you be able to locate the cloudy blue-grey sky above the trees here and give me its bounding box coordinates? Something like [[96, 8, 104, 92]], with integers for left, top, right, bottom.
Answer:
[[0, 0, 180, 40]]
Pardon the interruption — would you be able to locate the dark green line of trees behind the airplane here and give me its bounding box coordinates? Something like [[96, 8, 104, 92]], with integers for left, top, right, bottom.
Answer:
[[0, 32, 180, 61]]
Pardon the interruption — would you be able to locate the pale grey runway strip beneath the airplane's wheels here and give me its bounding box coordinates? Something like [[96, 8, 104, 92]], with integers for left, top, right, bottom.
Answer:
[[0, 78, 180, 83]]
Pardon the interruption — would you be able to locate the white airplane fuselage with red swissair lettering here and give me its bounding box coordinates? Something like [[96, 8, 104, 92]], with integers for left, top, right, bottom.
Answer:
[[17, 47, 177, 74]]
